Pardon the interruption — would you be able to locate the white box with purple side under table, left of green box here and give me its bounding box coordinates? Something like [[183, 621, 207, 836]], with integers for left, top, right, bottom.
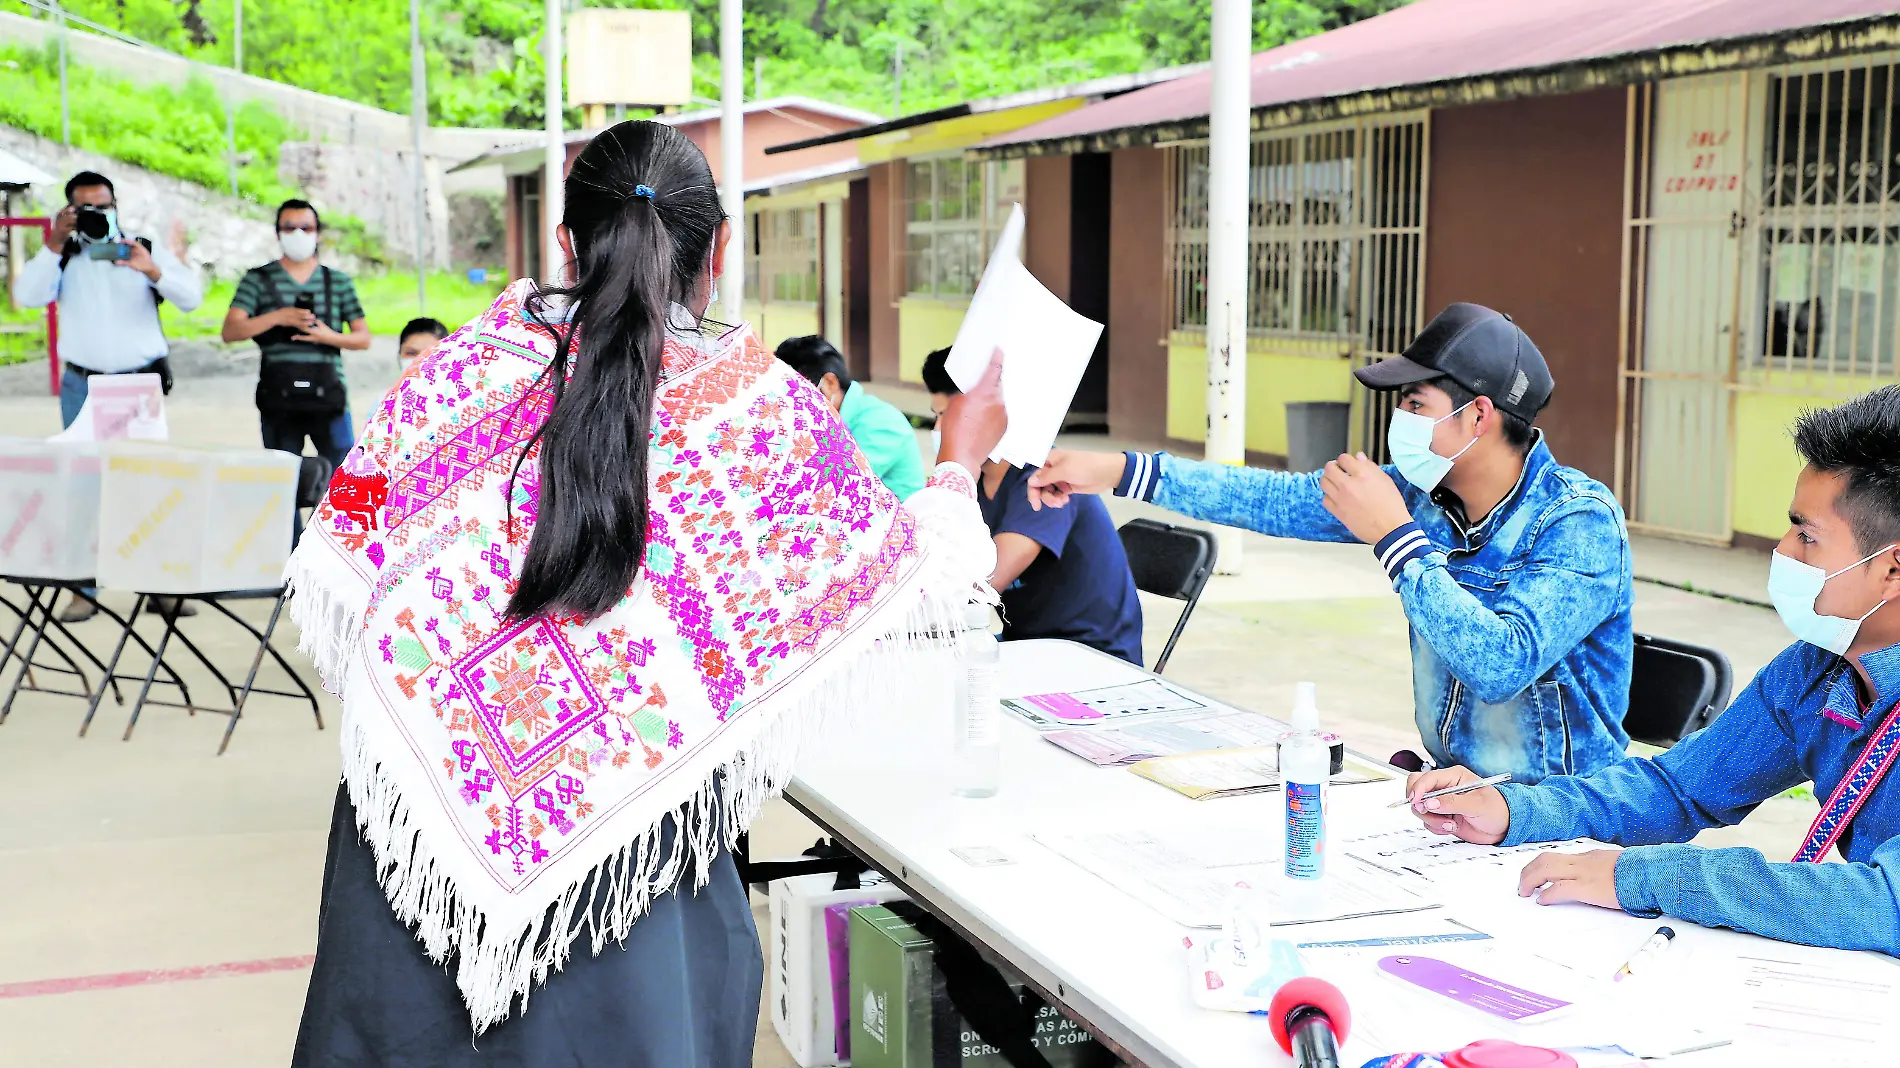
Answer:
[[768, 874, 904, 1068]]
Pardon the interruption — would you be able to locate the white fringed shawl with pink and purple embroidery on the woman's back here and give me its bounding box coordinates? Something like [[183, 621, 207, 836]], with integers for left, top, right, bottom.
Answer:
[[287, 281, 994, 1032]]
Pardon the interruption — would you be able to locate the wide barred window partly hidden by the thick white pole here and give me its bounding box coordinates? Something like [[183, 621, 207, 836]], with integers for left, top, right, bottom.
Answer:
[[1167, 118, 1425, 352]]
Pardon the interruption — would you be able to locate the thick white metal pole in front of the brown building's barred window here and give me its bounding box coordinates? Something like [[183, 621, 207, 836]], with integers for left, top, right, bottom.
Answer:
[[1207, 0, 1254, 574]]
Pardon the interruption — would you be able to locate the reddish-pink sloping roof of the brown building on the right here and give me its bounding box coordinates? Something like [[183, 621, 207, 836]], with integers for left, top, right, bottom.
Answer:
[[977, 0, 1900, 156]]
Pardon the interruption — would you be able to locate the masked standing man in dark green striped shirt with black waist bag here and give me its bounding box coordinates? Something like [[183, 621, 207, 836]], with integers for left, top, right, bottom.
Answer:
[[222, 200, 369, 467]]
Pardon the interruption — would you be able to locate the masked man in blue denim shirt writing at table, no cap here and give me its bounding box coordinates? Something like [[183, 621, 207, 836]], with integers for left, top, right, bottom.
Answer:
[[1406, 386, 1900, 956]]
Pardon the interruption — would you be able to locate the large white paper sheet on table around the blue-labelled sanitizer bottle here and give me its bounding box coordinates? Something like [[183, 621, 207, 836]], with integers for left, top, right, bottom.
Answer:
[[1032, 827, 1438, 929]]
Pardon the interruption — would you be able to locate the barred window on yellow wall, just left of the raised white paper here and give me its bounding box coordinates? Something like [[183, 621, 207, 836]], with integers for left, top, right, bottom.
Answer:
[[903, 156, 1022, 298]]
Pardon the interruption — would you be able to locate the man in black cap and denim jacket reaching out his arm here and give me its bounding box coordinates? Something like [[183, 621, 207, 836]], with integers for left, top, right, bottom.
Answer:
[[1030, 304, 1632, 783]]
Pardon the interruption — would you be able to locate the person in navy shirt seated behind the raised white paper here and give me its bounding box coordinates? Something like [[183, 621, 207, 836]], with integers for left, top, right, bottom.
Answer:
[[923, 348, 1142, 667]]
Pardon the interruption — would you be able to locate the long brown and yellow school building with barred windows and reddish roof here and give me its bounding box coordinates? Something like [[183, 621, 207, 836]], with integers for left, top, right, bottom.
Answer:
[[779, 0, 1900, 545]]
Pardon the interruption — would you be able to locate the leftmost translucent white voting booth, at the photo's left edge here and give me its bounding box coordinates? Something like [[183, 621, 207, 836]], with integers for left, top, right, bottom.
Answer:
[[0, 437, 99, 582]]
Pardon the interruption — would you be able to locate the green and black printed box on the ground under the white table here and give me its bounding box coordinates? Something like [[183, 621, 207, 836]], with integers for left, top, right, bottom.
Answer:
[[851, 903, 1115, 1068]]
